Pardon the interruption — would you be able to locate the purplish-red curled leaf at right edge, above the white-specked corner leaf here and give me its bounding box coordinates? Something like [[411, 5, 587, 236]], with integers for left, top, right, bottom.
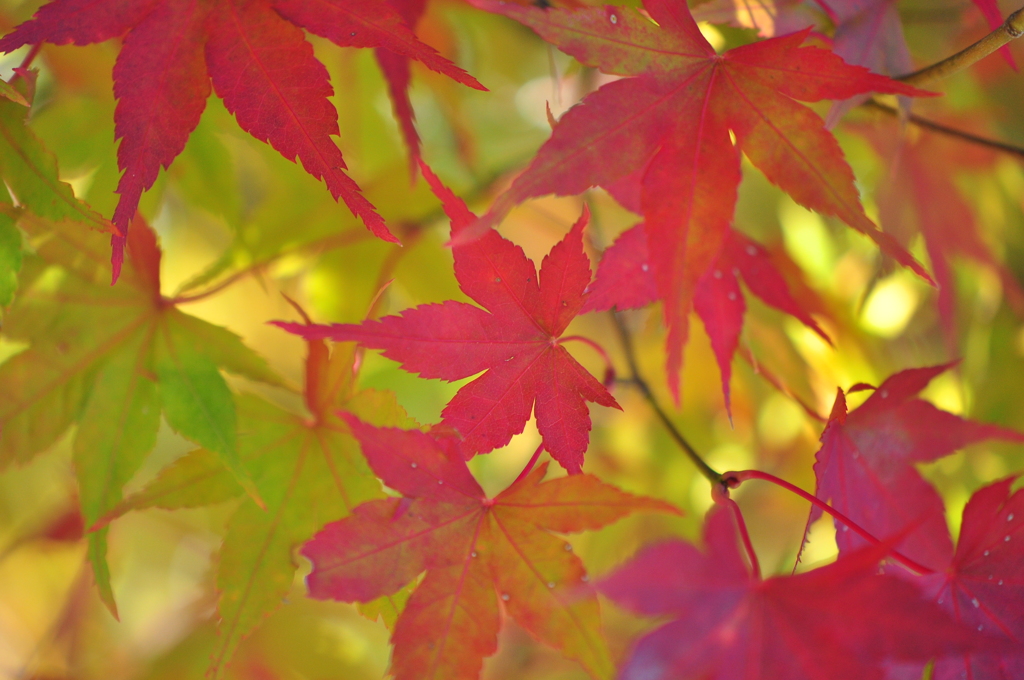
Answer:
[[809, 364, 1024, 570]]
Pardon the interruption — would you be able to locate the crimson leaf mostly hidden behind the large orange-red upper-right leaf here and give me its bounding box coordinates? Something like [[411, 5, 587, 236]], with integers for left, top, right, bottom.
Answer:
[[583, 225, 830, 410]]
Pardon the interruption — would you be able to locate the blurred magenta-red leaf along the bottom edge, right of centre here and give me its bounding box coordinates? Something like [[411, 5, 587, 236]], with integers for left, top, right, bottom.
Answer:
[[597, 501, 988, 680]]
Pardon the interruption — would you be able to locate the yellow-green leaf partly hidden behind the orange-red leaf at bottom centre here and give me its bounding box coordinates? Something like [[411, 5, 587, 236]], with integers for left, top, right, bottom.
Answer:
[[100, 333, 416, 678]]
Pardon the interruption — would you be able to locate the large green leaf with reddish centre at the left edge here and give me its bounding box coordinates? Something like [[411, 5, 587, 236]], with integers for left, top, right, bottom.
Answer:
[[0, 214, 282, 615]]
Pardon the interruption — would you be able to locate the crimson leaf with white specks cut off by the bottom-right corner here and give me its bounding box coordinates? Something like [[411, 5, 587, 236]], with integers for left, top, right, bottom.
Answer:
[[889, 477, 1024, 680]]
